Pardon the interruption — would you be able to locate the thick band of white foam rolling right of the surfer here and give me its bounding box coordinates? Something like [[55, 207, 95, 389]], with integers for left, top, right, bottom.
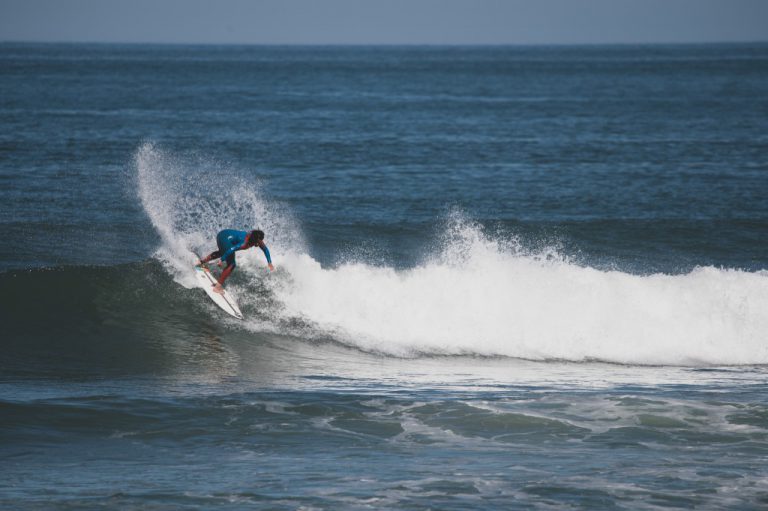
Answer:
[[268, 218, 768, 365]]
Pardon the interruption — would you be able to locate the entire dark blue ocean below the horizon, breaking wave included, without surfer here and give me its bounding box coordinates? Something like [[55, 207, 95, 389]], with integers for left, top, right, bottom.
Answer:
[[0, 43, 768, 510]]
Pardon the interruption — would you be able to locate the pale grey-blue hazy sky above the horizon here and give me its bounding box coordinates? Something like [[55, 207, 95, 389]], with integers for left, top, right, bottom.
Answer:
[[0, 0, 768, 45]]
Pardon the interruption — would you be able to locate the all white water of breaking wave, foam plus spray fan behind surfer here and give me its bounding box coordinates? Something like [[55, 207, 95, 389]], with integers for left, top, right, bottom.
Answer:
[[130, 144, 768, 365]]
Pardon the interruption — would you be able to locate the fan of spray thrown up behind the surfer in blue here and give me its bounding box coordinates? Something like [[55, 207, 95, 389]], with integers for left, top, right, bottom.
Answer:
[[134, 142, 303, 286]]
